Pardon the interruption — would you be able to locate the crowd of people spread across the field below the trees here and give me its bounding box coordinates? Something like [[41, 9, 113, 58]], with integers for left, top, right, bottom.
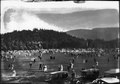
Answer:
[[1, 48, 118, 82]]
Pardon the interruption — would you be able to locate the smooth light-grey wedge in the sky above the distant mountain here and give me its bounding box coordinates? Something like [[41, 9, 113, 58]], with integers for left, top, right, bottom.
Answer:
[[37, 9, 119, 30]]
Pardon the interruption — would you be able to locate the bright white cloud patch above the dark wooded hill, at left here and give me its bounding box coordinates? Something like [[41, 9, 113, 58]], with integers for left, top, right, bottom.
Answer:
[[2, 10, 63, 33]]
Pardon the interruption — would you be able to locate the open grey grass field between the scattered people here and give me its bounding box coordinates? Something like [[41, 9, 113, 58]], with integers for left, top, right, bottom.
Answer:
[[1, 51, 117, 84]]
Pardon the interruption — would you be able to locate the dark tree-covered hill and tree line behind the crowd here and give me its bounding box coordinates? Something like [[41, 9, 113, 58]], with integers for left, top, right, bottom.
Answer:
[[1, 28, 118, 51]]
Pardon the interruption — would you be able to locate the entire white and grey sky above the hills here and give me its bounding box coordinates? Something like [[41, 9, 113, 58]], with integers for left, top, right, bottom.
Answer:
[[0, 0, 119, 33]]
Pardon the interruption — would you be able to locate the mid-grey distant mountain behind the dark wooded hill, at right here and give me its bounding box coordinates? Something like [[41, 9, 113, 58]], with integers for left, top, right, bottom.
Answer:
[[67, 27, 120, 41]]
